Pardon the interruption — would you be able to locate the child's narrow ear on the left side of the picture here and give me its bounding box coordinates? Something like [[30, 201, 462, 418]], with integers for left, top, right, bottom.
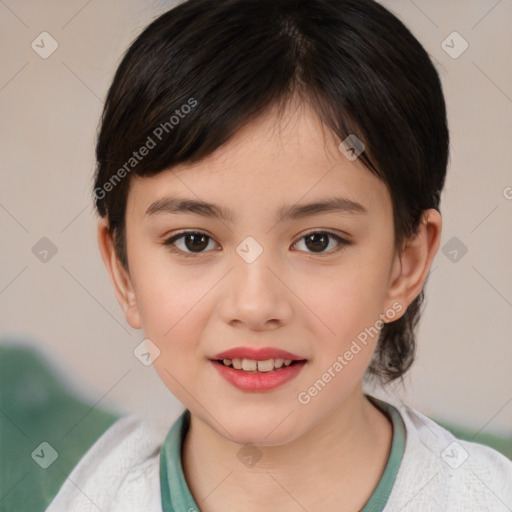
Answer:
[[98, 218, 141, 329]]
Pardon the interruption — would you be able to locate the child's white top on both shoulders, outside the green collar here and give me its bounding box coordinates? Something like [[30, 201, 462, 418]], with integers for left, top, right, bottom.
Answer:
[[46, 396, 512, 512]]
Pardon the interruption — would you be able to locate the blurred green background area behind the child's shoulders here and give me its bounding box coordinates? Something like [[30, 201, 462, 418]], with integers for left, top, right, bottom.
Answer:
[[0, 340, 512, 512]]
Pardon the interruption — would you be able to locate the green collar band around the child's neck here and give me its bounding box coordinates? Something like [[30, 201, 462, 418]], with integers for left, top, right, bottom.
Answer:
[[160, 396, 405, 512]]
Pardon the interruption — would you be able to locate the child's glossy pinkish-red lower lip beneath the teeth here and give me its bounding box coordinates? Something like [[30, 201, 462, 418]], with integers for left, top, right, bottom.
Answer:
[[212, 361, 306, 393]]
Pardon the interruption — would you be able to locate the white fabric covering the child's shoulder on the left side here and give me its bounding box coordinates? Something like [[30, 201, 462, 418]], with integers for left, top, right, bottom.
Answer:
[[46, 414, 172, 512]]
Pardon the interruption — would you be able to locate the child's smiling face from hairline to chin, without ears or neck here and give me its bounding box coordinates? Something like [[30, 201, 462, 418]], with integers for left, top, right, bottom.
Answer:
[[114, 101, 407, 445]]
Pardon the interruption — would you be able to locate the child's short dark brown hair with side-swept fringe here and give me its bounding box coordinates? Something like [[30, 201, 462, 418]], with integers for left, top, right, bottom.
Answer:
[[94, 0, 449, 381]]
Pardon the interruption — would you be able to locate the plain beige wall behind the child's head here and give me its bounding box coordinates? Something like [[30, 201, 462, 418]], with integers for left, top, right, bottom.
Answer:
[[0, 0, 512, 433]]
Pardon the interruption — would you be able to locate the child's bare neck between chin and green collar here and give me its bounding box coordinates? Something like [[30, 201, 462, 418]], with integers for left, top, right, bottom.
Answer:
[[182, 388, 392, 512]]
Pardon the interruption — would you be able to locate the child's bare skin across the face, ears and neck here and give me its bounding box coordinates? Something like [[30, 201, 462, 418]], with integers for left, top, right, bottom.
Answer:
[[98, 97, 441, 512]]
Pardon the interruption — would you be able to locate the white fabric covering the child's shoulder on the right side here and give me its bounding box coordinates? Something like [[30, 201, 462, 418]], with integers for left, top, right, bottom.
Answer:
[[385, 403, 512, 512]]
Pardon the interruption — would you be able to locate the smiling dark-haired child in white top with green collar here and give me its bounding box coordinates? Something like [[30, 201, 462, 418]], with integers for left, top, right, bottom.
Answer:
[[47, 0, 512, 512]]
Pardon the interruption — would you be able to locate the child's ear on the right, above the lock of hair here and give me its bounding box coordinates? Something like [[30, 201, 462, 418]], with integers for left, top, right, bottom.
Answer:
[[386, 208, 442, 320]]
